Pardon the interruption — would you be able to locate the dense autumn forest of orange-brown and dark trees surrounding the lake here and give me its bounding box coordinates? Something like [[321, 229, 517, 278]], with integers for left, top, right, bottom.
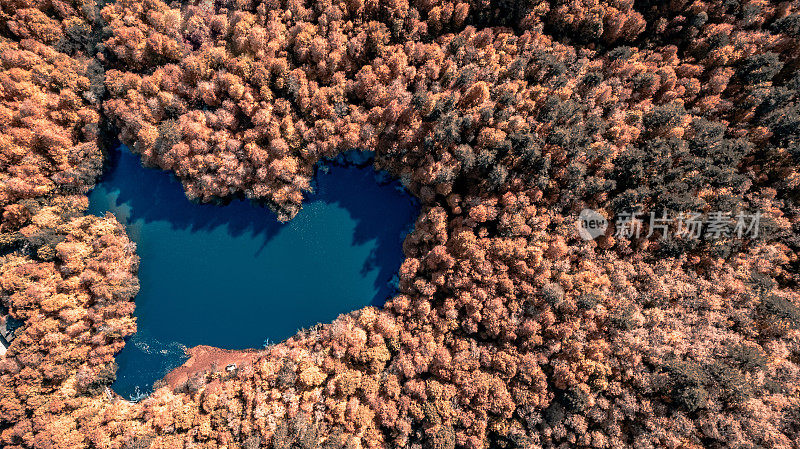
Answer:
[[0, 0, 800, 449]]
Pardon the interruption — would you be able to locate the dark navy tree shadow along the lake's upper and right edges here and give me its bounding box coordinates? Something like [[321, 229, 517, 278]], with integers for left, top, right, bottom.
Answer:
[[89, 145, 419, 307]]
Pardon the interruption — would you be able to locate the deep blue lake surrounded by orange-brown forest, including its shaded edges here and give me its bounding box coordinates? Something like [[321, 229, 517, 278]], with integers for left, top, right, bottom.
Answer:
[[89, 146, 419, 397]]
